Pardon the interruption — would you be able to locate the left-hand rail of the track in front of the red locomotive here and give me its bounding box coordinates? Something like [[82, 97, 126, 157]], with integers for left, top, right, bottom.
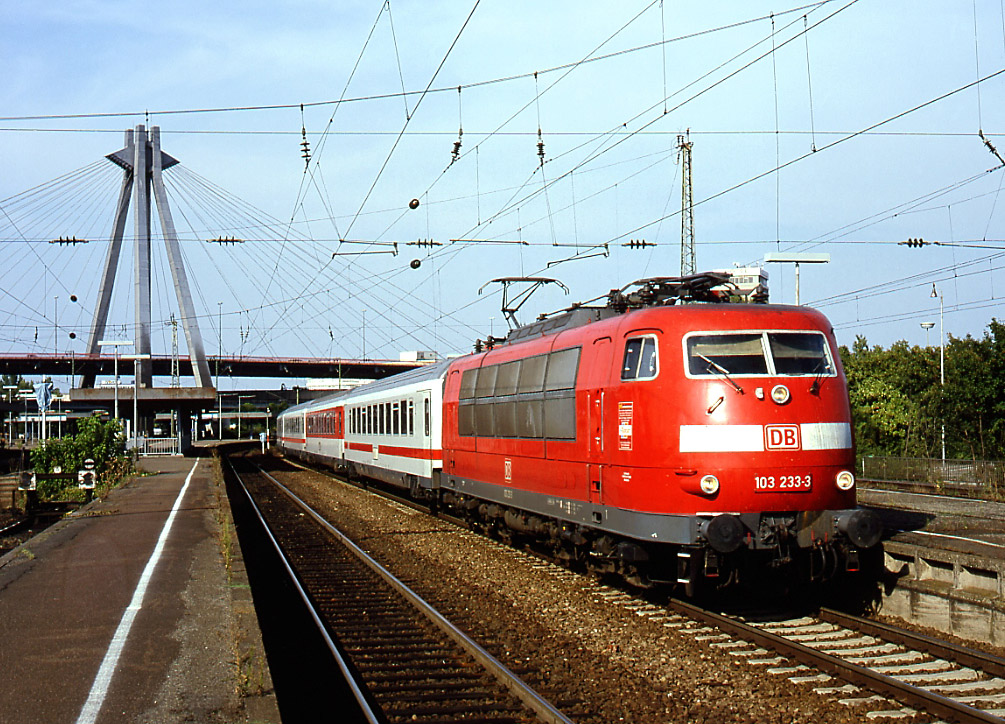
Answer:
[[669, 600, 1002, 724]]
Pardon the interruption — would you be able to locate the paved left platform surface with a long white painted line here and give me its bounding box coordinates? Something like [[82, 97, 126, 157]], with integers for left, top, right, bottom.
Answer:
[[0, 458, 278, 724]]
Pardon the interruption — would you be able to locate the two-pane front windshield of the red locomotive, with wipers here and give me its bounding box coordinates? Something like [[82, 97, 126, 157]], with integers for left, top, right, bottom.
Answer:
[[686, 332, 835, 377]]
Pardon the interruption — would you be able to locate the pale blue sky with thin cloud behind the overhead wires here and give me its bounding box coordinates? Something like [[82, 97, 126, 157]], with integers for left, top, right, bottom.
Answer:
[[0, 0, 1005, 390]]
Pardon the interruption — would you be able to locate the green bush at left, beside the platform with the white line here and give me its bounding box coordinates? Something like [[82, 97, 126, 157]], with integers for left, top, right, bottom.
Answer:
[[31, 417, 132, 500]]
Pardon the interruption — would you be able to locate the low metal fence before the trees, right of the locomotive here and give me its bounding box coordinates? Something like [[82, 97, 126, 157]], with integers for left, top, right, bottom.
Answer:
[[859, 456, 1005, 497]]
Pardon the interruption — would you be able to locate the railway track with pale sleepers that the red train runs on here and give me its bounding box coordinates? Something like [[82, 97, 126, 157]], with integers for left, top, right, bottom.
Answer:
[[263, 454, 1005, 722]]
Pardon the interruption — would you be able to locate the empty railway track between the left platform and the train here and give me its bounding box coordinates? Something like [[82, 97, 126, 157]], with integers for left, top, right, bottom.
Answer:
[[228, 459, 571, 724]]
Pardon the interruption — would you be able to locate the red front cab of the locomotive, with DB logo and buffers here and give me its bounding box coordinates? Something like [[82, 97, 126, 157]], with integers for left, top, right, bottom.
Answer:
[[618, 305, 881, 584]]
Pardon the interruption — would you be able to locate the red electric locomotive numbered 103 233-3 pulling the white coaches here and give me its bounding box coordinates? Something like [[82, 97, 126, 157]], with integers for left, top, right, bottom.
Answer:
[[279, 274, 880, 593]]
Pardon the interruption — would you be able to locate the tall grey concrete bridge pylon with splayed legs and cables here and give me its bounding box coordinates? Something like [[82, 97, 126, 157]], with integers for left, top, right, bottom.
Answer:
[[80, 125, 213, 387]]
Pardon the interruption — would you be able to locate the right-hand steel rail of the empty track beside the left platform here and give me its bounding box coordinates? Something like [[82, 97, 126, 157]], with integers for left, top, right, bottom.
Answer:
[[255, 466, 575, 724]]
